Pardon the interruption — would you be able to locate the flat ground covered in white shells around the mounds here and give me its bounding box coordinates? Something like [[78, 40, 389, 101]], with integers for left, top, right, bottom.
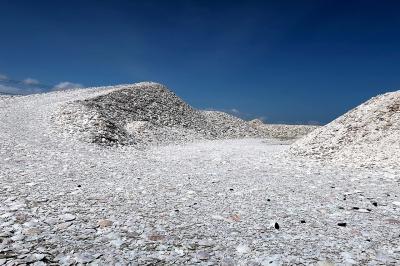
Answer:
[[0, 90, 400, 265]]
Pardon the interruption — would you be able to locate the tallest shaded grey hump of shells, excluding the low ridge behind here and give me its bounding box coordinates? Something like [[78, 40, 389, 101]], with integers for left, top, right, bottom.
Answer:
[[56, 82, 211, 145]]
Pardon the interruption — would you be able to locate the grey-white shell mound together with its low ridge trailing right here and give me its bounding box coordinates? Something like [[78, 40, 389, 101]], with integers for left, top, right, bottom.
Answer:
[[54, 82, 314, 145]]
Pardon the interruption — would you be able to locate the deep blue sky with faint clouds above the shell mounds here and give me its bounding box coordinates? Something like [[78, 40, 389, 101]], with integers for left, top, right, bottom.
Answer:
[[0, 0, 400, 124]]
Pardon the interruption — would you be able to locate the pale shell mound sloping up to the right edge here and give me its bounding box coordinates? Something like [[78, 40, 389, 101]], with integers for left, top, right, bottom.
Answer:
[[290, 91, 400, 167]]
